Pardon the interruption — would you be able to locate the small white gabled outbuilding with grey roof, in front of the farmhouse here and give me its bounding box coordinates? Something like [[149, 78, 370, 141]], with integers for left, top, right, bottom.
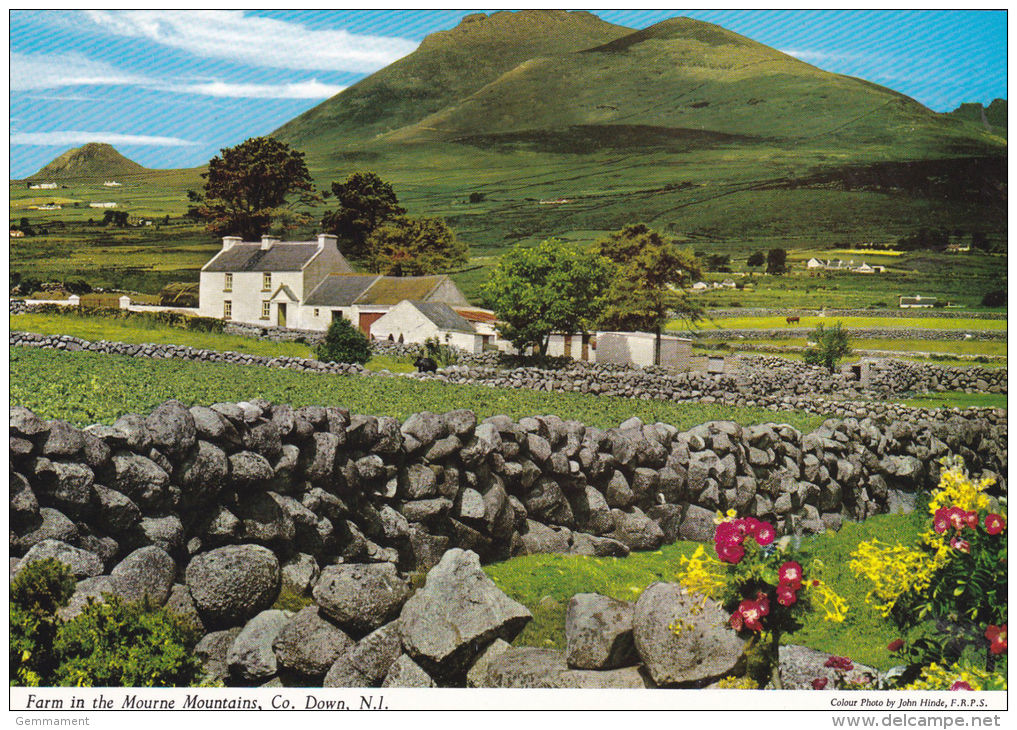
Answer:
[[370, 299, 483, 353]]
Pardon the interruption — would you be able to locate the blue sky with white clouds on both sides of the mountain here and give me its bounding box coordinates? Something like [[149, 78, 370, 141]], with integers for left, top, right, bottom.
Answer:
[[10, 10, 1007, 178]]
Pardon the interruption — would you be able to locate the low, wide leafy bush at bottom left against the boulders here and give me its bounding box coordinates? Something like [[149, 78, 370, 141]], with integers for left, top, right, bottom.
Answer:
[[53, 596, 201, 687]]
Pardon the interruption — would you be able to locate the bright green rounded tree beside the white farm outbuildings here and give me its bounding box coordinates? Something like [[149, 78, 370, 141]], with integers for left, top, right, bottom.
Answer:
[[482, 238, 613, 355]]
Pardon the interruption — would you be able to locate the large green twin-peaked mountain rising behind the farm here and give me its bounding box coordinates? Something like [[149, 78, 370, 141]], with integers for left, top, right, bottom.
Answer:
[[274, 10, 1007, 290]]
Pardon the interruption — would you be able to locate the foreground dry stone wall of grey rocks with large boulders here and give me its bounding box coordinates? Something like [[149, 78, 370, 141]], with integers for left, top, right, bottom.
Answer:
[[9, 401, 1007, 687]]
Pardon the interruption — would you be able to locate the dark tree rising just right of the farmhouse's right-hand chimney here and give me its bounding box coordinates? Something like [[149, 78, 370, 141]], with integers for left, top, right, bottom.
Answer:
[[321, 172, 406, 259]]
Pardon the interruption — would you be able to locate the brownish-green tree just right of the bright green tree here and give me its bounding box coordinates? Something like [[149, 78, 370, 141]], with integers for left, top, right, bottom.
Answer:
[[600, 224, 703, 362]]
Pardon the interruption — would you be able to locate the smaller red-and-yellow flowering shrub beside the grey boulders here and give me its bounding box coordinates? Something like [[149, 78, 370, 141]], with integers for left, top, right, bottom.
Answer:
[[681, 510, 847, 688]]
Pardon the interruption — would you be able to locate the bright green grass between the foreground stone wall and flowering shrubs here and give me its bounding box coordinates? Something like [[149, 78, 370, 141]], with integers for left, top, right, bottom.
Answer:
[[484, 512, 925, 670]]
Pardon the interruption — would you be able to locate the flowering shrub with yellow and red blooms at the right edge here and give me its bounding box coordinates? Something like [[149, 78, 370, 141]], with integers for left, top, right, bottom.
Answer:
[[850, 458, 1007, 689]]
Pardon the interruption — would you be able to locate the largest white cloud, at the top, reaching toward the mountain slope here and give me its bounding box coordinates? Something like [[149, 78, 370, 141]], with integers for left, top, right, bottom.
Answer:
[[82, 10, 417, 72]]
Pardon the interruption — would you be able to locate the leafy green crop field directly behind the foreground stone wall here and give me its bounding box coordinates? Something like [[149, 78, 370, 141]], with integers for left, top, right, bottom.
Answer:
[[10, 348, 825, 431]]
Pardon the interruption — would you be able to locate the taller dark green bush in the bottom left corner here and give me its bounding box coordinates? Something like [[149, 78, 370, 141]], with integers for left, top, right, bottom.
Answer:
[[8, 558, 76, 686]]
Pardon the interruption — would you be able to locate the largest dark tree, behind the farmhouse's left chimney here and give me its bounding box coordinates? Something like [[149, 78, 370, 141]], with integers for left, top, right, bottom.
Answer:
[[194, 137, 318, 241]]
